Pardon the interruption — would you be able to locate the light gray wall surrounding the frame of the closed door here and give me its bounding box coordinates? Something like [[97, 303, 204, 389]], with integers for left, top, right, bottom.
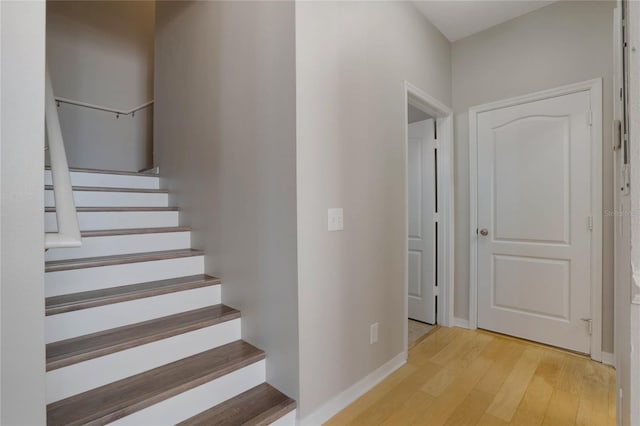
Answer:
[[452, 1, 615, 352]]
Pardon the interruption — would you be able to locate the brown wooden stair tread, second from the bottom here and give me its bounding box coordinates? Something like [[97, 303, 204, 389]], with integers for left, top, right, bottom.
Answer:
[[47, 340, 264, 426]]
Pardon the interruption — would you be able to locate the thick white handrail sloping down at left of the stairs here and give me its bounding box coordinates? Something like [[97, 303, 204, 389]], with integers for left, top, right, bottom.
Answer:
[[44, 69, 82, 249]]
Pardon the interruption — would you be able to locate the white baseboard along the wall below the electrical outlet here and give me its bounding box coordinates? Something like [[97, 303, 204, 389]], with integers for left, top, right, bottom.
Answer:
[[298, 352, 407, 426]]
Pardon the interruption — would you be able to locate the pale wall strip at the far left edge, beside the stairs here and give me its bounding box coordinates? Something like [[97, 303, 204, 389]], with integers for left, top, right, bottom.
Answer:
[[0, 1, 46, 425]]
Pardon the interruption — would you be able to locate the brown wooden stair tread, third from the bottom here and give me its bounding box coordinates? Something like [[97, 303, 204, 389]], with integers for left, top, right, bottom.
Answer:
[[46, 305, 240, 371]]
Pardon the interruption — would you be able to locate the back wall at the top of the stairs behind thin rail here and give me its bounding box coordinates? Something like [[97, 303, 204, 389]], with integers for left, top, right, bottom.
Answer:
[[47, 1, 155, 171]]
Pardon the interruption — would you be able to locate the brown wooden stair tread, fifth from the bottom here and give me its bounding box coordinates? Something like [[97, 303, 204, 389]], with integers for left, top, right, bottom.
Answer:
[[45, 249, 204, 272]]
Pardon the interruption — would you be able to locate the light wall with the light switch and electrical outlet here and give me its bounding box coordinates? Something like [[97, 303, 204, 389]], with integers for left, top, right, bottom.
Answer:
[[296, 2, 451, 418]]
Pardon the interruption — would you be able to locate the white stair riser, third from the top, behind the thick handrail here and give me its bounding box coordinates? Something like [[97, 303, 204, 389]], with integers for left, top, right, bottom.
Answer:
[[44, 211, 178, 232]]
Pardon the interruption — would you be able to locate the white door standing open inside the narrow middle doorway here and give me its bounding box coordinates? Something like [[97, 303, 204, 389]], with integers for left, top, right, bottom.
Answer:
[[408, 119, 436, 324]]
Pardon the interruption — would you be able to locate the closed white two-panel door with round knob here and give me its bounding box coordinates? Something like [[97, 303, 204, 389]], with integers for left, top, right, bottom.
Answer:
[[477, 92, 592, 353]]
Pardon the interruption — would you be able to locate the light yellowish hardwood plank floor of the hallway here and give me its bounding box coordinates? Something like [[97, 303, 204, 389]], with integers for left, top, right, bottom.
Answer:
[[326, 327, 616, 426]]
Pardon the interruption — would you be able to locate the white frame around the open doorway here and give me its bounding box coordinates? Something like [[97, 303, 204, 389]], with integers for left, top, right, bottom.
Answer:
[[403, 81, 455, 349]]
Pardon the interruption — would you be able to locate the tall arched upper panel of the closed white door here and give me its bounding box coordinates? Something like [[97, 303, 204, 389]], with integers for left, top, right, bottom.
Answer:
[[494, 117, 570, 244]]
